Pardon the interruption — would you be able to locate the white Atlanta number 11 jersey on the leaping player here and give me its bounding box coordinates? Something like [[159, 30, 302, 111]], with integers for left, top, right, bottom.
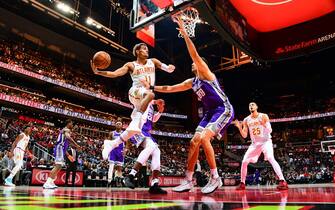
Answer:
[[130, 59, 156, 87]]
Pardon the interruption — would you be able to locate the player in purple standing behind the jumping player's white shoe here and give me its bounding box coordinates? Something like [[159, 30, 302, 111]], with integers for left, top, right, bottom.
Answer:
[[105, 120, 125, 186]]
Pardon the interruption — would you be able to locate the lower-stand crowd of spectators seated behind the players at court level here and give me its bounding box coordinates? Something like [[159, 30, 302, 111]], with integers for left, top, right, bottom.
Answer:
[[0, 116, 333, 187]]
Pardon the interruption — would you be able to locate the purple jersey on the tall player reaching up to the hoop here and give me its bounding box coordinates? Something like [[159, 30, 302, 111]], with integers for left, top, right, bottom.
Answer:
[[192, 77, 231, 111]]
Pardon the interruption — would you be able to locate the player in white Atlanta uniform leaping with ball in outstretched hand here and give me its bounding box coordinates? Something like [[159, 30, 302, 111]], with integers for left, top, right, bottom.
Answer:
[[91, 43, 175, 160]]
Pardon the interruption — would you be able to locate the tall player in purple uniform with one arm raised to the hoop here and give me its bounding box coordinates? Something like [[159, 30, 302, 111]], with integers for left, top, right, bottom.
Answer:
[[143, 19, 234, 194]]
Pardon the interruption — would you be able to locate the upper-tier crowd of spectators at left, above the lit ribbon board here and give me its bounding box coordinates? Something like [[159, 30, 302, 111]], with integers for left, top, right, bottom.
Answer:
[[0, 37, 186, 114]]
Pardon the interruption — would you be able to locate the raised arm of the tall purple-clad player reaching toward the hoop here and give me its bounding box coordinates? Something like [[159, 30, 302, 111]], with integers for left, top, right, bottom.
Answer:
[[173, 18, 215, 81]]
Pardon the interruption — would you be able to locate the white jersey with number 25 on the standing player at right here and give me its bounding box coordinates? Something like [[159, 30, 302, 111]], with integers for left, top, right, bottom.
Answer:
[[244, 113, 271, 143]]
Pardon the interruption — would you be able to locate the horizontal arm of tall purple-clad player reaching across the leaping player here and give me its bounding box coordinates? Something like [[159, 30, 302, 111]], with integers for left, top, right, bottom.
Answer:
[[141, 79, 193, 93]]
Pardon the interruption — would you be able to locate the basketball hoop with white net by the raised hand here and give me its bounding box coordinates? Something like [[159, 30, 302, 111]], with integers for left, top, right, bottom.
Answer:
[[173, 7, 200, 38]]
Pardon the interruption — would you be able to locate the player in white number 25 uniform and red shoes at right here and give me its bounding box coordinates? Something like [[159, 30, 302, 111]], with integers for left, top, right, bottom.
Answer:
[[233, 102, 288, 190]]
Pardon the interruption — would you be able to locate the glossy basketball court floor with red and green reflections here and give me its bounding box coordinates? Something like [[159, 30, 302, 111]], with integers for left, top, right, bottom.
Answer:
[[0, 184, 335, 210]]
